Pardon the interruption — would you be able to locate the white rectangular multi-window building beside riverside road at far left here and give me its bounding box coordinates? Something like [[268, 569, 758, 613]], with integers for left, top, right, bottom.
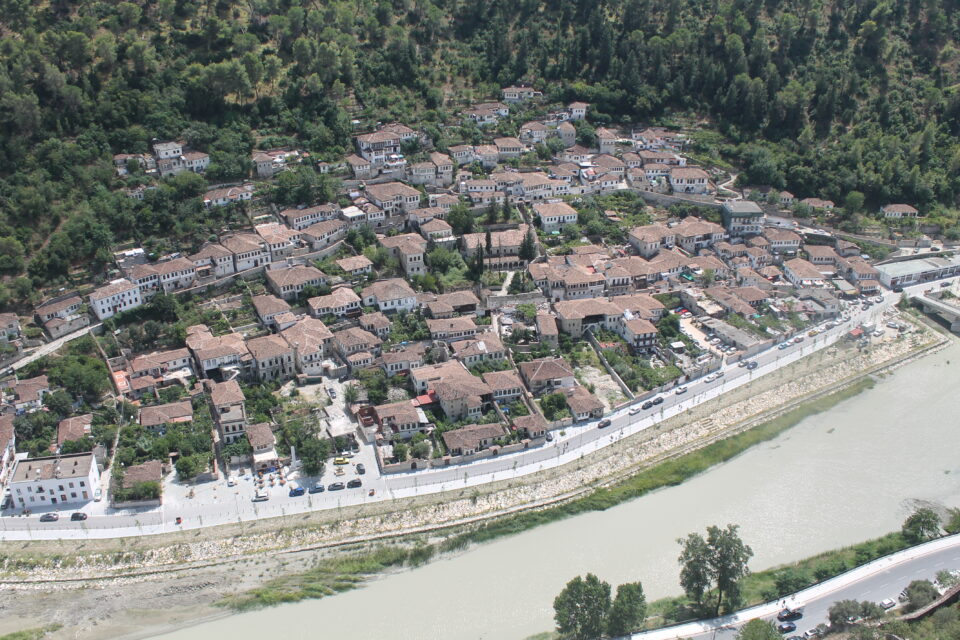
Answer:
[[9, 453, 100, 509]]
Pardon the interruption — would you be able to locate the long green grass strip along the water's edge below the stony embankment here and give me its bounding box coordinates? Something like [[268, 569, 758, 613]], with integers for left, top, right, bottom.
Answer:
[[441, 378, 873, 551]]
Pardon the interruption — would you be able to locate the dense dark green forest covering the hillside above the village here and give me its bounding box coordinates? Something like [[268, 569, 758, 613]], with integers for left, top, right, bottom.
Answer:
[[0, 0, 960, 306]]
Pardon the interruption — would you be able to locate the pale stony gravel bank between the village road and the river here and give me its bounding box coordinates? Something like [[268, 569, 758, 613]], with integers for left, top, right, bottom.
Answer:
[[0, 322, 945, 639]]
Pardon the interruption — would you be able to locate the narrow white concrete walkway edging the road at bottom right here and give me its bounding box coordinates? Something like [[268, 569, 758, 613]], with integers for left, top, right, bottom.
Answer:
[[630, 534, 960, 640]]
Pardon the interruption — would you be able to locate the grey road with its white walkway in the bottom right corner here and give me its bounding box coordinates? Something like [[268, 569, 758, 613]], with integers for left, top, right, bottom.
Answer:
[[631, 535, 960, 640]]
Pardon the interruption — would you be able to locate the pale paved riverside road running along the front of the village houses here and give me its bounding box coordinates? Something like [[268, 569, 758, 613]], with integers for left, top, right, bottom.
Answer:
[[0, 285, 930, 540]]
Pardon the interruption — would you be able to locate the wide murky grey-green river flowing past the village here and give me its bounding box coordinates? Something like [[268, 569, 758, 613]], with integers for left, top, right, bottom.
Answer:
[[162, 345, 960, 640]]
